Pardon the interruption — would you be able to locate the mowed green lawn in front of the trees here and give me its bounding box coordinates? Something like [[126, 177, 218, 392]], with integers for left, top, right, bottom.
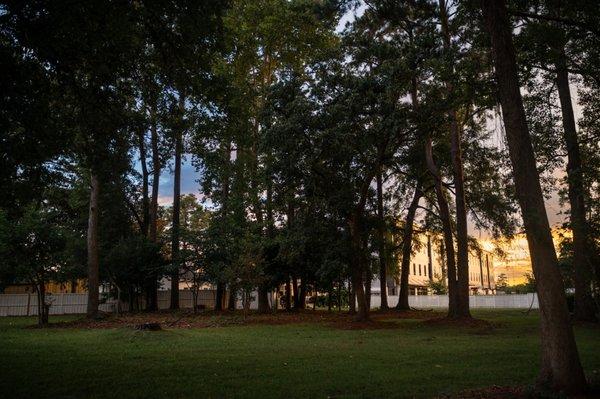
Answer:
[[0, 310, 600, 399]]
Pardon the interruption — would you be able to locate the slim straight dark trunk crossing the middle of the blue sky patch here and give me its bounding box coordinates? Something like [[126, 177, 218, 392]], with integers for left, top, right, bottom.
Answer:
[[171, 94, 184, 310]]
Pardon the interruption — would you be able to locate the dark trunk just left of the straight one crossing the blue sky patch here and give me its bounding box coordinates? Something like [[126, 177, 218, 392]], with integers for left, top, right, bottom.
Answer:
[[146, 104, 161, 311]]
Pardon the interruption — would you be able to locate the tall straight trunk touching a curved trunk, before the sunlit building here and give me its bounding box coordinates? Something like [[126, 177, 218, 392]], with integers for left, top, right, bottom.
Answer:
[[439, 0, 471, 318]]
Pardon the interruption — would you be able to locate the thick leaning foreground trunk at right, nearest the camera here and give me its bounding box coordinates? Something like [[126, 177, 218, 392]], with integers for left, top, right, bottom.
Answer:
[[481, 0, 587, 393]]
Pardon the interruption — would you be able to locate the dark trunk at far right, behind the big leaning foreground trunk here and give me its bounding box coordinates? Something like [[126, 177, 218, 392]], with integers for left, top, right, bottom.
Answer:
[[556, 46, 597, 321]]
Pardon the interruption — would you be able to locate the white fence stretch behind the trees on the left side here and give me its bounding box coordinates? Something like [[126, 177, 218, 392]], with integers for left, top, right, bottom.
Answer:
[[0, 290, 220, 316]]
